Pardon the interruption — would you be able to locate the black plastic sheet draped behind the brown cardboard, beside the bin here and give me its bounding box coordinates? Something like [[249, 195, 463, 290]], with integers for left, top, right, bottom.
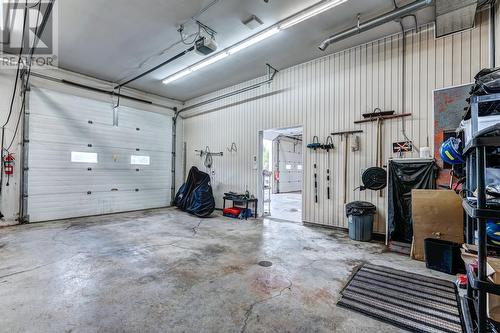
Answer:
[[387, 160, 438, 243]]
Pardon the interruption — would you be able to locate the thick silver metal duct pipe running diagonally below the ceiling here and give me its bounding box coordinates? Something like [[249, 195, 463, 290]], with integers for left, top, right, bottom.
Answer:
[[319, 0, 432, 51]]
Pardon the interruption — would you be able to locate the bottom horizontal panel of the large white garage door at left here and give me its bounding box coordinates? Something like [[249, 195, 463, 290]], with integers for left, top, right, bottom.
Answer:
[[29, 189, 170, 221]]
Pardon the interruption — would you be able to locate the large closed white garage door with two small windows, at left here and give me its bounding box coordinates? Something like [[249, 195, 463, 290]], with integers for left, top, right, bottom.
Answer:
[[25, 88, 172, 222]]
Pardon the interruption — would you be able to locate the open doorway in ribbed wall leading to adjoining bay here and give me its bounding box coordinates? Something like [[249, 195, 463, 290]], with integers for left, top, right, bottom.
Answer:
[[261, 127, 304, 223]]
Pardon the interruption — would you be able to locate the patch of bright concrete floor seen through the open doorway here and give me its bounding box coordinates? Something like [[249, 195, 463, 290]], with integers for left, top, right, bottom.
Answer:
[[271, 192, 302, 223]]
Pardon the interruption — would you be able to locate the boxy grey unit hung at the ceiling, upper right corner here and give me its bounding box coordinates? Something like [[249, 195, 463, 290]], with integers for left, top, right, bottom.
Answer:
[[436, 0, 477, 38]]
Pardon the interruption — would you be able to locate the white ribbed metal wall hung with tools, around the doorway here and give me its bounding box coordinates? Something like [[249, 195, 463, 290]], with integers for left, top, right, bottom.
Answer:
[[183, 12, 489, 233]]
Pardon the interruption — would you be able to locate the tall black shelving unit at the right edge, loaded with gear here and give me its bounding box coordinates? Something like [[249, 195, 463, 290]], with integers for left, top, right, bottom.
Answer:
[[462, 94, 500, 333]]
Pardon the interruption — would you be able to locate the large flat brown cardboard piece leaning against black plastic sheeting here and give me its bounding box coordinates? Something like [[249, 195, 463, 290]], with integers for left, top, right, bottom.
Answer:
[[411, 190, 464, 261]]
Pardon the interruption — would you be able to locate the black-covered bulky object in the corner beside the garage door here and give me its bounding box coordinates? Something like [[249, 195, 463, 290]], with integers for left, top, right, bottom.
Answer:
[[175, 167, 215, 217]]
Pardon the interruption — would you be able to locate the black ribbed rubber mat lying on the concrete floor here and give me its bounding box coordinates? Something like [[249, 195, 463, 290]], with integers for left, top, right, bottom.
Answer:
[[337, 264, 463, 333]]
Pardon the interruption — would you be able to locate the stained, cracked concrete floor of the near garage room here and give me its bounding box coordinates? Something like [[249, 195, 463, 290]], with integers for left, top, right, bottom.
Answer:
[[0, 209, 452, 333]]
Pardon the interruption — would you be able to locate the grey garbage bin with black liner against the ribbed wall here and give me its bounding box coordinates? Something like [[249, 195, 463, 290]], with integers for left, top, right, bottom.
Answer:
[[346, 201, 377, 242]]
